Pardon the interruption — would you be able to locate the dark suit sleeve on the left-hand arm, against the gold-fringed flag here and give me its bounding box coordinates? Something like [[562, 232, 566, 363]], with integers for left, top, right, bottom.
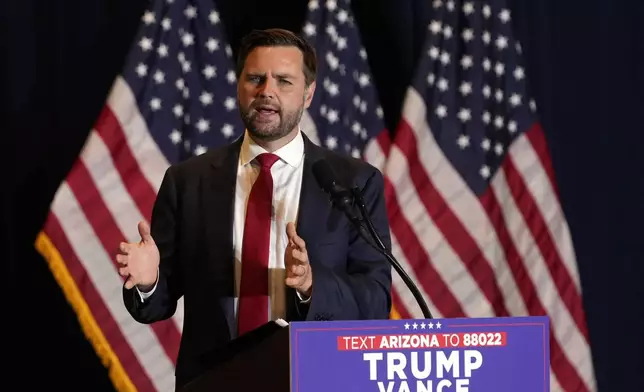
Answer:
[[123, 168, 183, 324]]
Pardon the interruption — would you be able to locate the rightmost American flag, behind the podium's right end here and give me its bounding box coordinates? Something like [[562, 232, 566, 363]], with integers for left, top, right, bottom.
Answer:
[[374, 0, 597, 391]]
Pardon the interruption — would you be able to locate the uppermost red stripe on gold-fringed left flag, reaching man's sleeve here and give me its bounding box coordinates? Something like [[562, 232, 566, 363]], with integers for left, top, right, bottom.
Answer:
[[96, 105, 156, 220]]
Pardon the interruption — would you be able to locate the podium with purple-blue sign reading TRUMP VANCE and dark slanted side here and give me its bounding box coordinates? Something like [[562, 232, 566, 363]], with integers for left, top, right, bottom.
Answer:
[[182, 317, 550, 392]]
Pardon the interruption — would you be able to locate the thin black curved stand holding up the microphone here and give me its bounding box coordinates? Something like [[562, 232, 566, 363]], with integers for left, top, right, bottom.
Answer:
[[351, 185, 433, 319]]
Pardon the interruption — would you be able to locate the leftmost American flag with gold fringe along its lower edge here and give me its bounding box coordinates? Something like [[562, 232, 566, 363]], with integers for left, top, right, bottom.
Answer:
[[37, 0, 244, 391]]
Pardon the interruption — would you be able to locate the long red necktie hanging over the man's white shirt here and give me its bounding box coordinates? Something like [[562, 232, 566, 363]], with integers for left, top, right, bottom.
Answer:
[[237, 153, 279, 335]]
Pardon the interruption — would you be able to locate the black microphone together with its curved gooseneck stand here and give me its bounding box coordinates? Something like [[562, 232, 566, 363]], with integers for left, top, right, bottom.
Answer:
[[312, 159, 433, 319]]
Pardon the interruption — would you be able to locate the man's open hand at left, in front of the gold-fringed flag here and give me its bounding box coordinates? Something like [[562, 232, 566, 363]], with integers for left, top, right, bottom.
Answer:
[[116, 222, 160, 292]]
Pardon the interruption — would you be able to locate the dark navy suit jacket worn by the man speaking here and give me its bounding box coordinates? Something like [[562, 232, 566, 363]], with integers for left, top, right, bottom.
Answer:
[[123, 134, 391, 388]]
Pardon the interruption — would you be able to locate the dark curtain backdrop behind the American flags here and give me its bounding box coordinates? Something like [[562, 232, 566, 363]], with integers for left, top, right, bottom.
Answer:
[[0, 0, 644, 392]]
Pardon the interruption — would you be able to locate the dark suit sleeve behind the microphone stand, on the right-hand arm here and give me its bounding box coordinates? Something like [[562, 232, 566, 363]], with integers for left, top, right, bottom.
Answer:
[[299, 170, 391, 320]]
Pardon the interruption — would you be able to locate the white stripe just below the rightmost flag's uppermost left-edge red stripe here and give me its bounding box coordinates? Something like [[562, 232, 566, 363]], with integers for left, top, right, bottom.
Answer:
[[387, 145, 494, 317]]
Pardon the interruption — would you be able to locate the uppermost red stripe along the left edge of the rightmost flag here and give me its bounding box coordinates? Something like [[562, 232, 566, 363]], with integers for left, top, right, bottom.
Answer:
[[394, 119, 509, 317]]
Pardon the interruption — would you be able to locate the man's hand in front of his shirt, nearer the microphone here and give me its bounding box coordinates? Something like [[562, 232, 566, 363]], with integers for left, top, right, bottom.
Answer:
[[284, 222, 313, 297]]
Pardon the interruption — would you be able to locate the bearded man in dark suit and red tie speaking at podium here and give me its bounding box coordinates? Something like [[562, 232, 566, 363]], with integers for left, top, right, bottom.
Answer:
[[116, 29, 391, 386]]
